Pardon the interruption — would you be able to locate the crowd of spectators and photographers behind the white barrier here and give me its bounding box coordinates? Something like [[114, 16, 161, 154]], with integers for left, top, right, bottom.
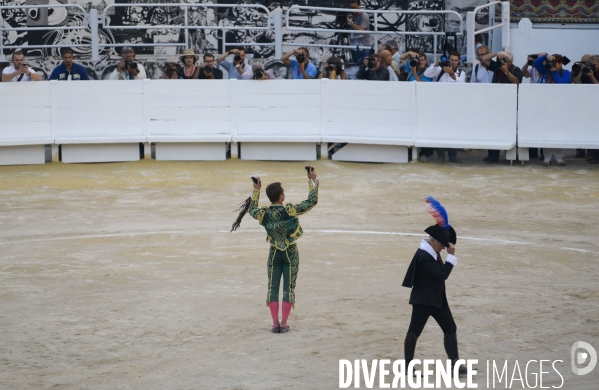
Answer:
[[2, 38, 599, 166]]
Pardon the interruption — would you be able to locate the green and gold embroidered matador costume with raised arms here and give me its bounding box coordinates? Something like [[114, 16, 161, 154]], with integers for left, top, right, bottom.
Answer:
[[249, 179, 318, 306]]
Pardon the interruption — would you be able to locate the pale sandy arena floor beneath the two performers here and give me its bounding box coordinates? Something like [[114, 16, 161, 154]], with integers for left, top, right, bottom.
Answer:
[[0, 152, 599, 390]]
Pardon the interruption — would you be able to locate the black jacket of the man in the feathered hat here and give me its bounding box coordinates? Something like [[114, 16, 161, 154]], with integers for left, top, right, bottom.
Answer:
[[402, 249, 453, 308]]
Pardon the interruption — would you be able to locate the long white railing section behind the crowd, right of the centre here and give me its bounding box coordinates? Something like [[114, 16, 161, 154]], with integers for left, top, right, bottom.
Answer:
[[285, 5, 464, 61]]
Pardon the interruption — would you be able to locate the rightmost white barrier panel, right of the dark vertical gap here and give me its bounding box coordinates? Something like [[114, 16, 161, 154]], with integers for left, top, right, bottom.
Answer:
[[518, 84, 599, 149]]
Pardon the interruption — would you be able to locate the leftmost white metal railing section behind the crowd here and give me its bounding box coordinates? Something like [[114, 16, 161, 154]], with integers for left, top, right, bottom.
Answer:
[[0, 3, 92, 61]]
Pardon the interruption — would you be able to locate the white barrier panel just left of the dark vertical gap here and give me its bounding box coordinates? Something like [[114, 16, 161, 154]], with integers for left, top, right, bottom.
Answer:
[[414, 83, 518, 150]]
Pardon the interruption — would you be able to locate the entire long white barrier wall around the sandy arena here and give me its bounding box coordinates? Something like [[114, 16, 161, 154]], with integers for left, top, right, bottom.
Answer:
[[0, 80, 599, 164]]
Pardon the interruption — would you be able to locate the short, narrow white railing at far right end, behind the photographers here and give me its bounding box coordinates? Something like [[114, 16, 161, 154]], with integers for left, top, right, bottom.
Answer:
[[466, 1, 510, 64]]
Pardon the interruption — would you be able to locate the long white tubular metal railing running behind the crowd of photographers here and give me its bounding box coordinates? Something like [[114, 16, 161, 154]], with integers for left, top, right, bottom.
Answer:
[[0, 3, 472, 61]]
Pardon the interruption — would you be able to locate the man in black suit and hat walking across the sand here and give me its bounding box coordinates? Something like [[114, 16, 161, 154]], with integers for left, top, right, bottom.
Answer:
[[402, 225, 466, 374]]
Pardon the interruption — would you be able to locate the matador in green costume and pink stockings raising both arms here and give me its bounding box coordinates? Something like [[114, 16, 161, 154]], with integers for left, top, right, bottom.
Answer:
[[231, 167, 318, 333]]
